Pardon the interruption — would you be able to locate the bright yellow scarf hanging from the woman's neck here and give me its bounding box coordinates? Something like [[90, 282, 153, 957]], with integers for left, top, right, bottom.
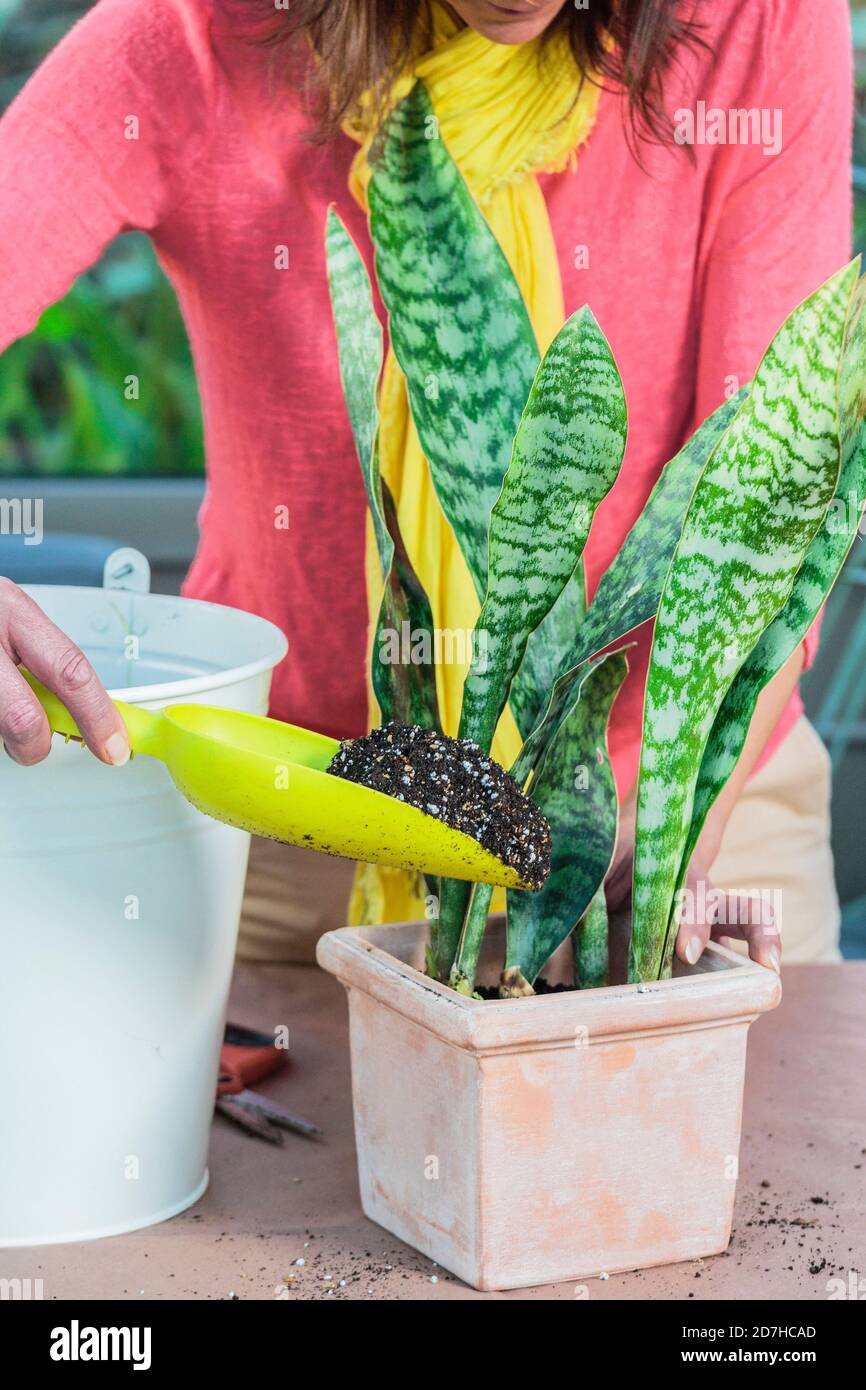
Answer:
[[345, 3, 598, 923]]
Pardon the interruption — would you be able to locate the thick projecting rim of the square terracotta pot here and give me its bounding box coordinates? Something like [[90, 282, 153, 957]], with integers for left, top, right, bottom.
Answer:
[[317, 915, 781, 1054]]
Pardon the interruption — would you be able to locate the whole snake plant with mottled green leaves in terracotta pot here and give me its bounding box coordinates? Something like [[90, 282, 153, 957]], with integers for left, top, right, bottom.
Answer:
[[325, 82, 866, 997]]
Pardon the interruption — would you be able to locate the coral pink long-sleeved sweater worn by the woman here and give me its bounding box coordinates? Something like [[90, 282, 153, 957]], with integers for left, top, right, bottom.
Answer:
[[0, 0, 852, 785]]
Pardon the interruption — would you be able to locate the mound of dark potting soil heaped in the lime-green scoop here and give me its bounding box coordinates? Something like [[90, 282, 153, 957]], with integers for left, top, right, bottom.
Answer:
[[328, 721, 550, 888]]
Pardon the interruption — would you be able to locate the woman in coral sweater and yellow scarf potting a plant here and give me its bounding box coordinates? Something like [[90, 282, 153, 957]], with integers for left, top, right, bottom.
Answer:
[[0, 0, 851, 969]]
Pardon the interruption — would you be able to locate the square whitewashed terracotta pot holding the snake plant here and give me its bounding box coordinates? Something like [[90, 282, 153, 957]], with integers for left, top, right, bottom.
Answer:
[[318, 919, 781, 1289]]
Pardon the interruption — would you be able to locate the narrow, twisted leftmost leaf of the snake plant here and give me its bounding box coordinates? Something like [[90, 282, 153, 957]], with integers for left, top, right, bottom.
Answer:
[[325, 210, 439, 728]]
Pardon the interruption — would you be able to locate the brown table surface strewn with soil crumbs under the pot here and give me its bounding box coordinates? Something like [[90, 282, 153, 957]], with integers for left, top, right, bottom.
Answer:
[[0, 962, 866, 1300]]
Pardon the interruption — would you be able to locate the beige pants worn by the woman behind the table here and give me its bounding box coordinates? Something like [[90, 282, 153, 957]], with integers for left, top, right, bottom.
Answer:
[[238, 719, 840, 963]]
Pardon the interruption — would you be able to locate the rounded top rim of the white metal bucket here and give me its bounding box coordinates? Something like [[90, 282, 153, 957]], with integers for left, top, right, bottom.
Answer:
[[21, 584, 289, 705]]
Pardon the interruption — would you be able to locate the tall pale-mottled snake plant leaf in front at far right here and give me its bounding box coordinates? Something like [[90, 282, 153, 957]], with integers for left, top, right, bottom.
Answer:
[[630, 265, 856, 980]]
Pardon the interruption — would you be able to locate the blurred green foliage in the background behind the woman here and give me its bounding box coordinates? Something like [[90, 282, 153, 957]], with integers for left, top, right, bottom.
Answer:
[[0, 0, 866, 477]]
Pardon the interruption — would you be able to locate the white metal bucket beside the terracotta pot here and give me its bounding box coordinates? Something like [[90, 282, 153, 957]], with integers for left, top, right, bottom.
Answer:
[[0, 567, 286, 1245]]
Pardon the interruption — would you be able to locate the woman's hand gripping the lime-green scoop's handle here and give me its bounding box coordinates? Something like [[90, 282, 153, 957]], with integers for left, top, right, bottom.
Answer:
[[0, 577, 129, 767]]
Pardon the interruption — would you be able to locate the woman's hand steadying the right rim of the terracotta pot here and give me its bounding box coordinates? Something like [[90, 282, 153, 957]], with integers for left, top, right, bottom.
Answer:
[[605, 794, 781, 981]]
